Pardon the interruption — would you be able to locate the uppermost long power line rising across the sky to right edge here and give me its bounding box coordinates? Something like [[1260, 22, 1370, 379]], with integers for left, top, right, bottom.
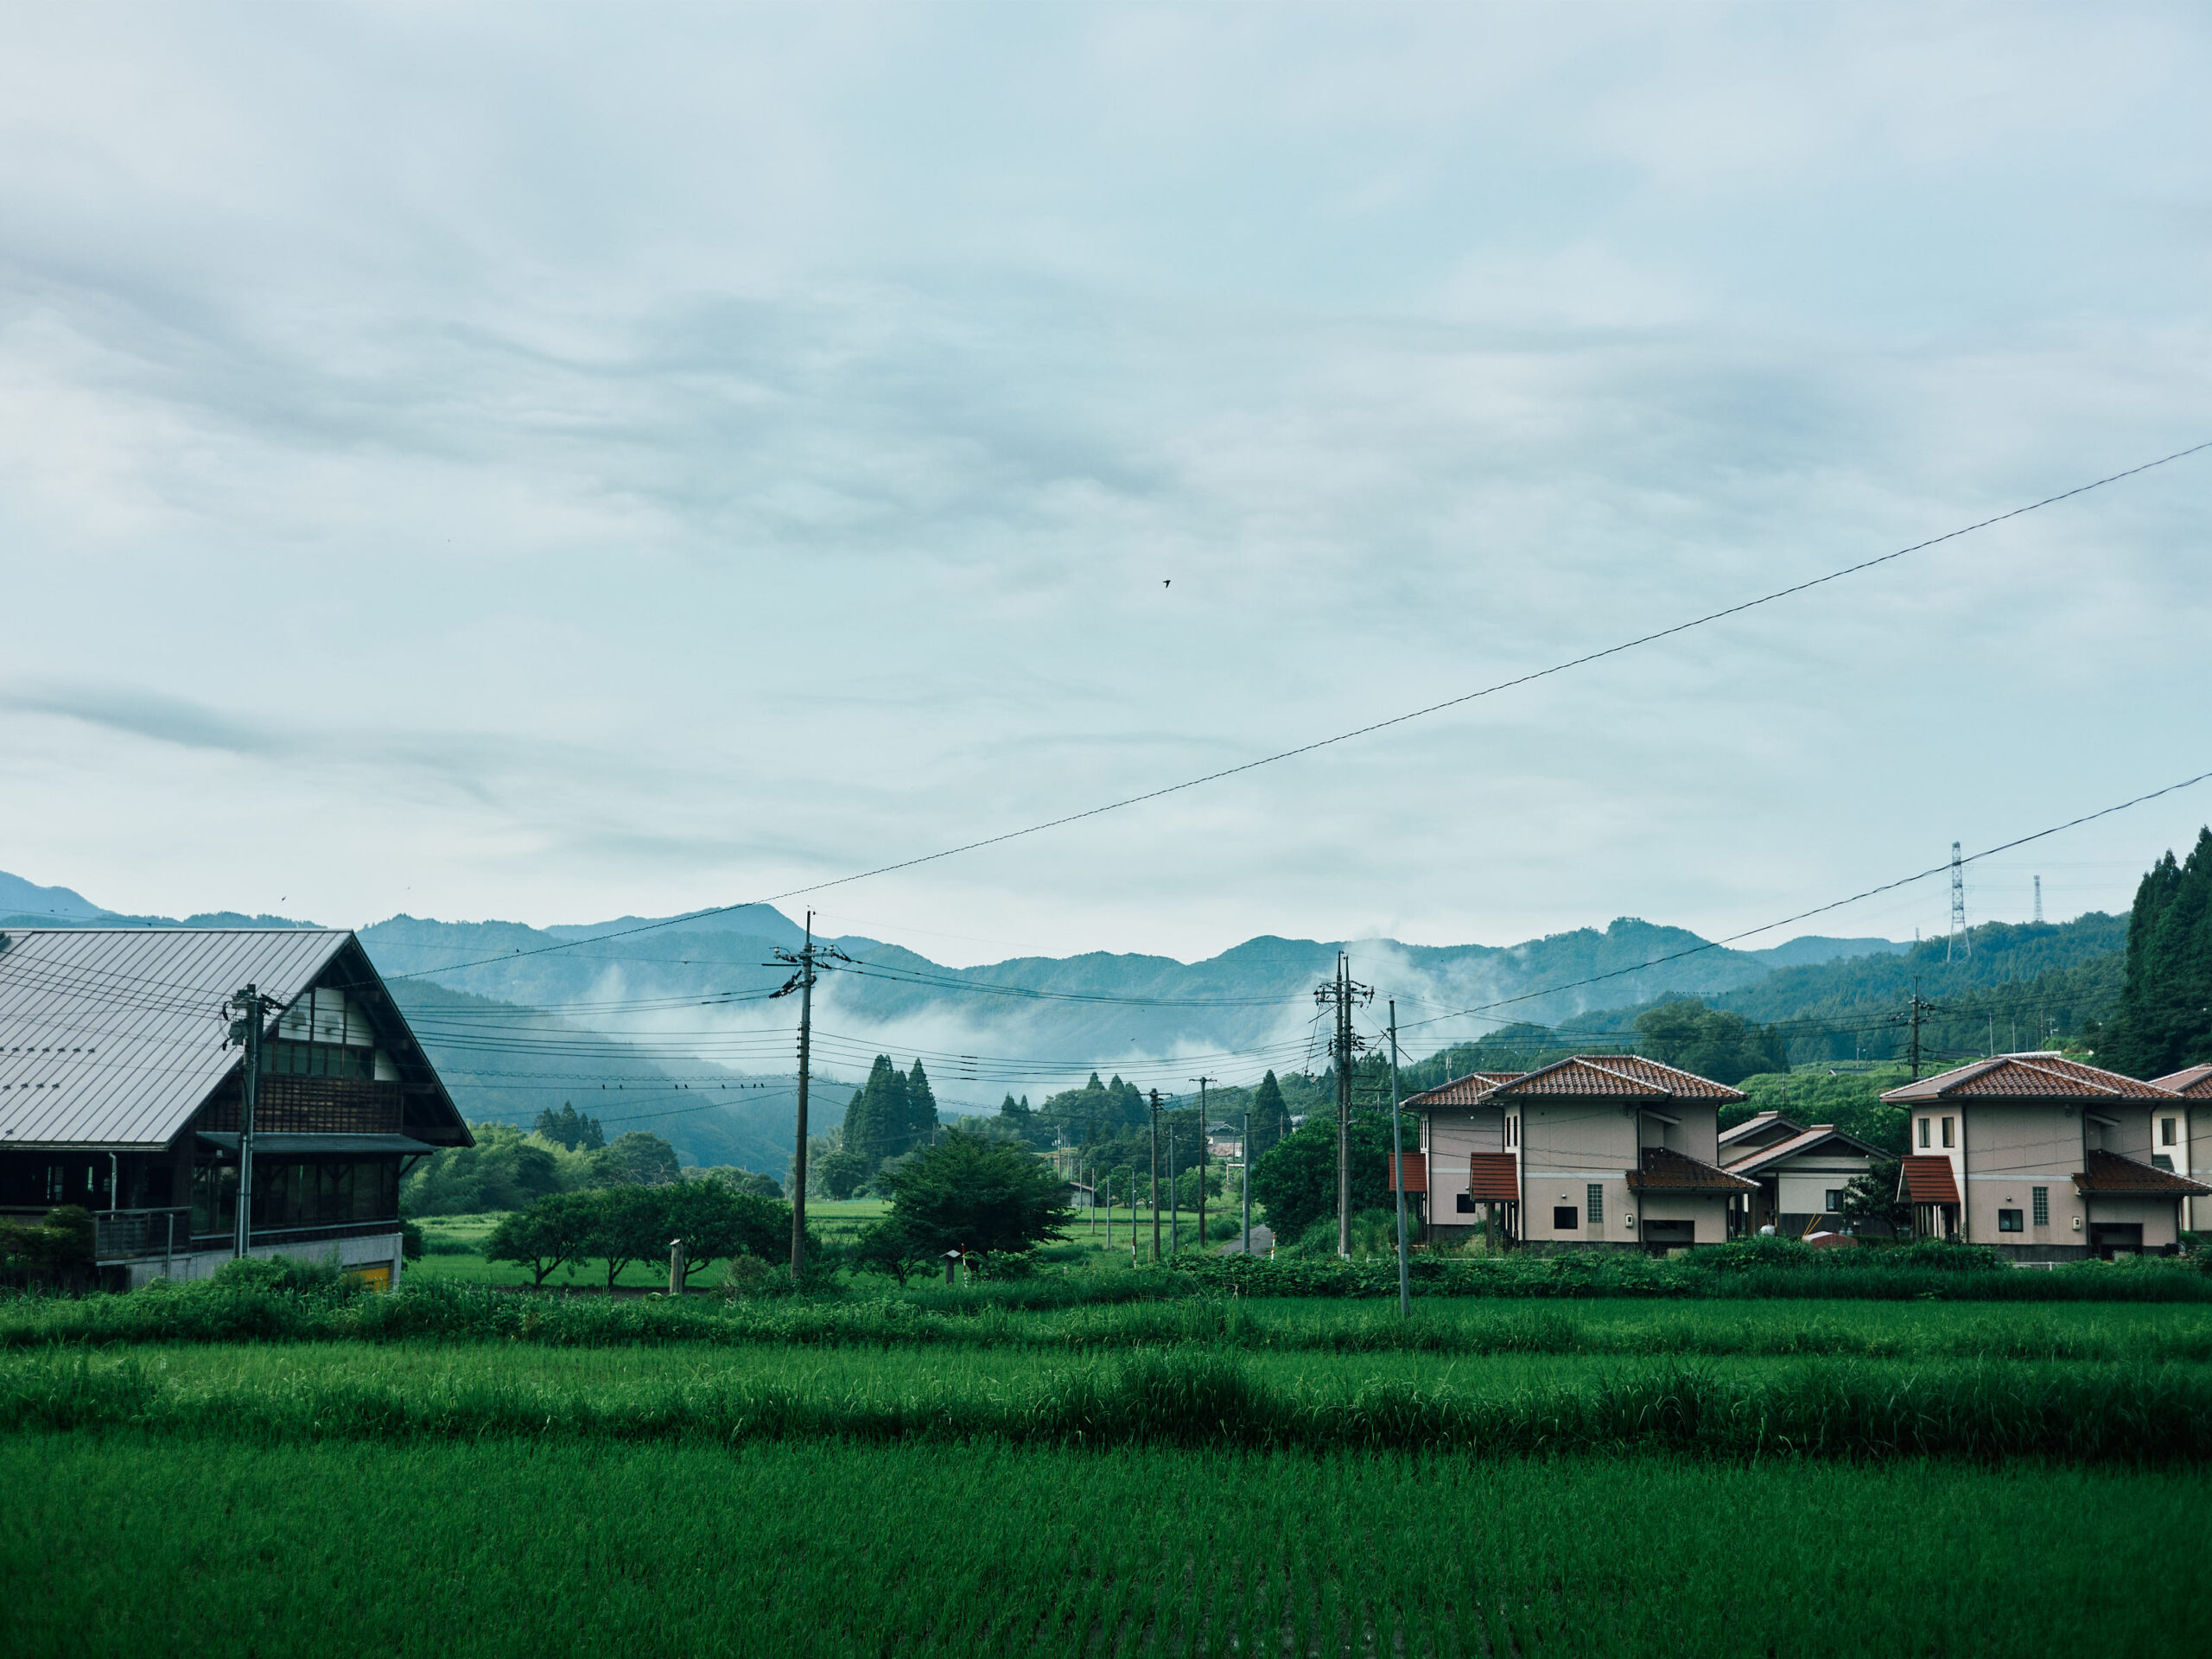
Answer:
[[391, 438, 2212, 980]]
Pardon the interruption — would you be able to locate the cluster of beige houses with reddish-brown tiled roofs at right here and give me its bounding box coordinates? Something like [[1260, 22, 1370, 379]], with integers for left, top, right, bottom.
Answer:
[[1405, 1053, 2212, 1263]]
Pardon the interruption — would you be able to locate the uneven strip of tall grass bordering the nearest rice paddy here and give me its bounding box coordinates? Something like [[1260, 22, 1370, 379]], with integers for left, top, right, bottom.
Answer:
[[0, 1350, 2212, 1465]]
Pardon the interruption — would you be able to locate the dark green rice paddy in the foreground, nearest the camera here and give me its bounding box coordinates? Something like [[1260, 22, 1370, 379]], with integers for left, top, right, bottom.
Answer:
[[0, 1433, 2203, 1659]]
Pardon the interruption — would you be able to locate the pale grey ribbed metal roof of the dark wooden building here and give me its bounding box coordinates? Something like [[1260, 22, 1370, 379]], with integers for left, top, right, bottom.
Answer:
[[0, 927, 352, 1146]]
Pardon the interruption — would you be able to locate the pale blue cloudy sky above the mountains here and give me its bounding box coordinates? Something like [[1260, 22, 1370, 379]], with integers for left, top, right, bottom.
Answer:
[[0, 4, 2212, 963]]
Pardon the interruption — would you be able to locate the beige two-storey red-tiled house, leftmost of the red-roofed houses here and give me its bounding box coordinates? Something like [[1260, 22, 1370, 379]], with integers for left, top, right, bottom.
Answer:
[[1405, 1055, 1757, 1249]]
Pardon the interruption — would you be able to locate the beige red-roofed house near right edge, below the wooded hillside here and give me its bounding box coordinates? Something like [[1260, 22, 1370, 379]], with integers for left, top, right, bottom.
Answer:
[[1883, 1053, 2212, 1261]]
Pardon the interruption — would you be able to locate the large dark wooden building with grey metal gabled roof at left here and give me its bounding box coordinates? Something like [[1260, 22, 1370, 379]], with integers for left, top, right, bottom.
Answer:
[[0, 927, 474, 1289]]
